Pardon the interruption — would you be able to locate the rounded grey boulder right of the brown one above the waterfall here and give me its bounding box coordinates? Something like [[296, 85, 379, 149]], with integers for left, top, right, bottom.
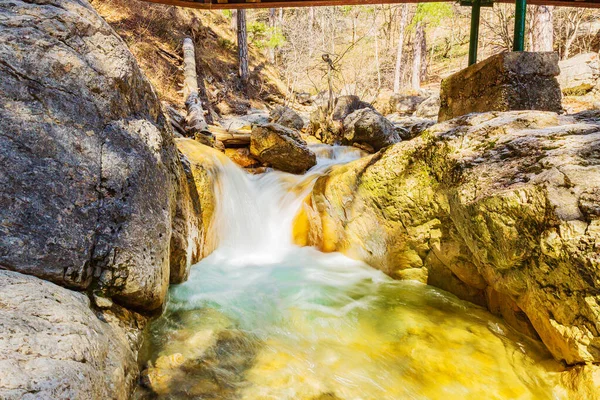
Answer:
[[343, 108, 400, 151]]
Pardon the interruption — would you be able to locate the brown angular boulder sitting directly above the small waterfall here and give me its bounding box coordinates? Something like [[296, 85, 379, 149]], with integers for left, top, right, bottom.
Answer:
[[250, 124, 317, 174]]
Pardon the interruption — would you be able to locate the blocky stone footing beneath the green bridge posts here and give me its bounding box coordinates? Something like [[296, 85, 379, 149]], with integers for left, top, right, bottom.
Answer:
[[438, 52, 562, 122]]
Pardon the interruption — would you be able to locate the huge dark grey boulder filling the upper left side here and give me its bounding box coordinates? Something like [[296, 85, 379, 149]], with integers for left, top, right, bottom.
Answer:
[[0, 0, 181, 310]]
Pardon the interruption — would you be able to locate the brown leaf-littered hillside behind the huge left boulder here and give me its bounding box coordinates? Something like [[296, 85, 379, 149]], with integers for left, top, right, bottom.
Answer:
[[91, 0, 285, 112]]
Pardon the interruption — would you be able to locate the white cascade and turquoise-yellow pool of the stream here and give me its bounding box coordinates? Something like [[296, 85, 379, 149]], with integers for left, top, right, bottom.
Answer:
[[136, 146, 567, 400]]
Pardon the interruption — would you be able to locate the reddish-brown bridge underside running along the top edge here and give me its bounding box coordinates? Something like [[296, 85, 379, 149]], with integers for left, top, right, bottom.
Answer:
[[144, 0, 600, 10]]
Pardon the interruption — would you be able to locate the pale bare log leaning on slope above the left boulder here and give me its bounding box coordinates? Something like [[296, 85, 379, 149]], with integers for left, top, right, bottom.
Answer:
[[183, 38, 212, 137]]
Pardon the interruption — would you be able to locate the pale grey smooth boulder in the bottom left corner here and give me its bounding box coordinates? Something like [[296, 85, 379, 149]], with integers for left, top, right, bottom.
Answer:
[[0, 271, 139, 400]]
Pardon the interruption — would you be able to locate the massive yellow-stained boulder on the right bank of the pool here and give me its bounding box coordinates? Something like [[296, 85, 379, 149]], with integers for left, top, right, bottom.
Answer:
[[295, 112, 600, 364]]
